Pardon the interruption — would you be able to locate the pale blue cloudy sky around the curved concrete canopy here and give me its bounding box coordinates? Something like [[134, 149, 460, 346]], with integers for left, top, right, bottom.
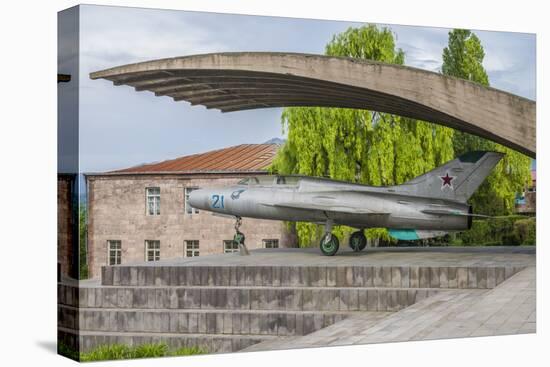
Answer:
[[71, 5, 536, 172]]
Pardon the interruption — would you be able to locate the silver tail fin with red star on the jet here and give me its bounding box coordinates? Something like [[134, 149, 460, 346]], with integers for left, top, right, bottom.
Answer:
[[402, 151, 504, 203]]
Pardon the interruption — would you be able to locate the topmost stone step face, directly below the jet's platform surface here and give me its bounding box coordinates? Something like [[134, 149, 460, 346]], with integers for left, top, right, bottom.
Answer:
[[101, 265, 524, 289]]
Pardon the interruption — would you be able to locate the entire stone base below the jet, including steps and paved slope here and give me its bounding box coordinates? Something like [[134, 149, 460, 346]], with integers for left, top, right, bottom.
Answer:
[[58, 247, 536, 353]]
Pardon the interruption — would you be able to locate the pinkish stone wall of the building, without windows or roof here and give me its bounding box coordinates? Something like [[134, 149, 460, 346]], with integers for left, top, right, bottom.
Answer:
[[88, 175, 294, 278]]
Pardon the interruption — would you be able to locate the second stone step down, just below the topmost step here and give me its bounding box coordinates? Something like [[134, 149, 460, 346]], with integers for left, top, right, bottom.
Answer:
[[58, 285, 438, 312]]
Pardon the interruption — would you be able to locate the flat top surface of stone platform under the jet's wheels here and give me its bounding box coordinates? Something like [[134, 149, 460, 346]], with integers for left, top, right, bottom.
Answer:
[[111, 245, 536, 267]]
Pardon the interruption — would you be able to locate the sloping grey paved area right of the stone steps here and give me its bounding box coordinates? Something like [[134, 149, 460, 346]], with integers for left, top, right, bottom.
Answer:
[[244, 267, 536, 351]]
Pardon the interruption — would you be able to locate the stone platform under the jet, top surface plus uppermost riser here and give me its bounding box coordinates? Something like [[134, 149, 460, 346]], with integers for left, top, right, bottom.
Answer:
[[96, 247, 535, 289]]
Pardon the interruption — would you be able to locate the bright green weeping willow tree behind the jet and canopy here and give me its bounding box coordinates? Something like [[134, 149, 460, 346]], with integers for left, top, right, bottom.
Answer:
[[272, 25, 453, 246]]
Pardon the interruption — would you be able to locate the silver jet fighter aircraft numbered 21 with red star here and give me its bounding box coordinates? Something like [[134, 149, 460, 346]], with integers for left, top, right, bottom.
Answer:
[[189, 151, 503, 256]]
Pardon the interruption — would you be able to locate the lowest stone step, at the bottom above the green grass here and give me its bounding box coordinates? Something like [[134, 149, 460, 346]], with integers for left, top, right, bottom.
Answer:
[[57, 328, 277, 353]]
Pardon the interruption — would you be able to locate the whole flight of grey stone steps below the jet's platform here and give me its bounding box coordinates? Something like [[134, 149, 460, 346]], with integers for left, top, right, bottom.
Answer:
[[58, 264, 522, 352]]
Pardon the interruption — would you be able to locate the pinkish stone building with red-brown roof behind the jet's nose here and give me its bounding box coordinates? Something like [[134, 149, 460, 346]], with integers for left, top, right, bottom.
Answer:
[[85, 144, 294, 278]]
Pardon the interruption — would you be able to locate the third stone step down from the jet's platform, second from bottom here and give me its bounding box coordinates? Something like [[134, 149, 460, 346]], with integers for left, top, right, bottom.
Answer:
[[58, 305, 382, 336]]
